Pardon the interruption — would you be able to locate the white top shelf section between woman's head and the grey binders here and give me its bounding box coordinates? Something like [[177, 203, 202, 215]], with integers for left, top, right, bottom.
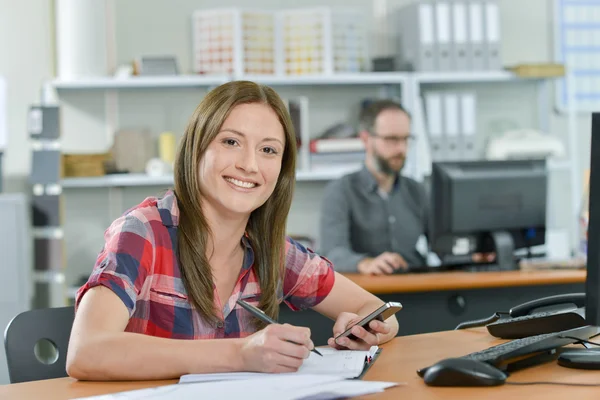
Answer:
[[240, 72, 410, 86]]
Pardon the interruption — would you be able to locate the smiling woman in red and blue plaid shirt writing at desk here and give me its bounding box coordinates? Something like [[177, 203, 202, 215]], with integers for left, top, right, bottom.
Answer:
[[67, 81, 398, 380]]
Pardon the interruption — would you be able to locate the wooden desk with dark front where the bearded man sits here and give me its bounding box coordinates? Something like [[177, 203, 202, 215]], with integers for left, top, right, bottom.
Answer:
[[279, 270, 586, 345]]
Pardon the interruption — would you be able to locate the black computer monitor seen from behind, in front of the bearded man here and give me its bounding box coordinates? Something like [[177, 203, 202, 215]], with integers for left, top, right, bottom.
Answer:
[[429, 160, 547, 270]]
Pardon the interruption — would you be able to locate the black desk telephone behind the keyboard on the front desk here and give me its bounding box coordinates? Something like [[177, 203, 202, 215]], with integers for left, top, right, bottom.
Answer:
[[456, 293, 586, 339]]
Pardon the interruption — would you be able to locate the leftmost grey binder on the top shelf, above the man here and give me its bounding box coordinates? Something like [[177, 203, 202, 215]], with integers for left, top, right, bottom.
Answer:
[[392, 0, 437, 71]]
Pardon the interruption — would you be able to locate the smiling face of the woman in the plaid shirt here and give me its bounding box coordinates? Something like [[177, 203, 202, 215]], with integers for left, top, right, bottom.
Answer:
[[198, 103, 285, 220]]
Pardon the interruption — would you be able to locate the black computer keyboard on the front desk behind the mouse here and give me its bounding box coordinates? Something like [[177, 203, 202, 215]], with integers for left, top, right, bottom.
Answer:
[[417, 325, 600, 377]]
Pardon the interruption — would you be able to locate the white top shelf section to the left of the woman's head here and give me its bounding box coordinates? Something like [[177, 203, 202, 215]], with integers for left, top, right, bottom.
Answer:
[[51, 75, 230, 90]]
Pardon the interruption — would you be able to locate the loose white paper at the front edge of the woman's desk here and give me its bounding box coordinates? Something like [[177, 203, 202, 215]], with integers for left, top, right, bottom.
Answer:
[[75, 374, 396, 400]]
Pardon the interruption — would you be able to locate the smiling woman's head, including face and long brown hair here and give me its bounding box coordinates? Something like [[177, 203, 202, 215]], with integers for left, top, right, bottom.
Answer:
[[175, 82, 296, 319]]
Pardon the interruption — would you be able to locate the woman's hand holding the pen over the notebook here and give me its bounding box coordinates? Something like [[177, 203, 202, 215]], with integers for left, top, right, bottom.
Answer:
[[241, 324, 314, 373]]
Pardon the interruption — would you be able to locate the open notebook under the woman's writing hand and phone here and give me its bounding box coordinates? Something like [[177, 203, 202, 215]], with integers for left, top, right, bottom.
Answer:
[[179, 346, 381, 383]]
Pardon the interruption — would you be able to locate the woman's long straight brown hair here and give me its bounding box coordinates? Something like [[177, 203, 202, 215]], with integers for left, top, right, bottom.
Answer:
[[174, 81, 296, 323]]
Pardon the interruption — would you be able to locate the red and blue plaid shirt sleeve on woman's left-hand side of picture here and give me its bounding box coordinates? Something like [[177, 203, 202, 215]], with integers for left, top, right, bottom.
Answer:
[[75, 214, 154, 317]]
